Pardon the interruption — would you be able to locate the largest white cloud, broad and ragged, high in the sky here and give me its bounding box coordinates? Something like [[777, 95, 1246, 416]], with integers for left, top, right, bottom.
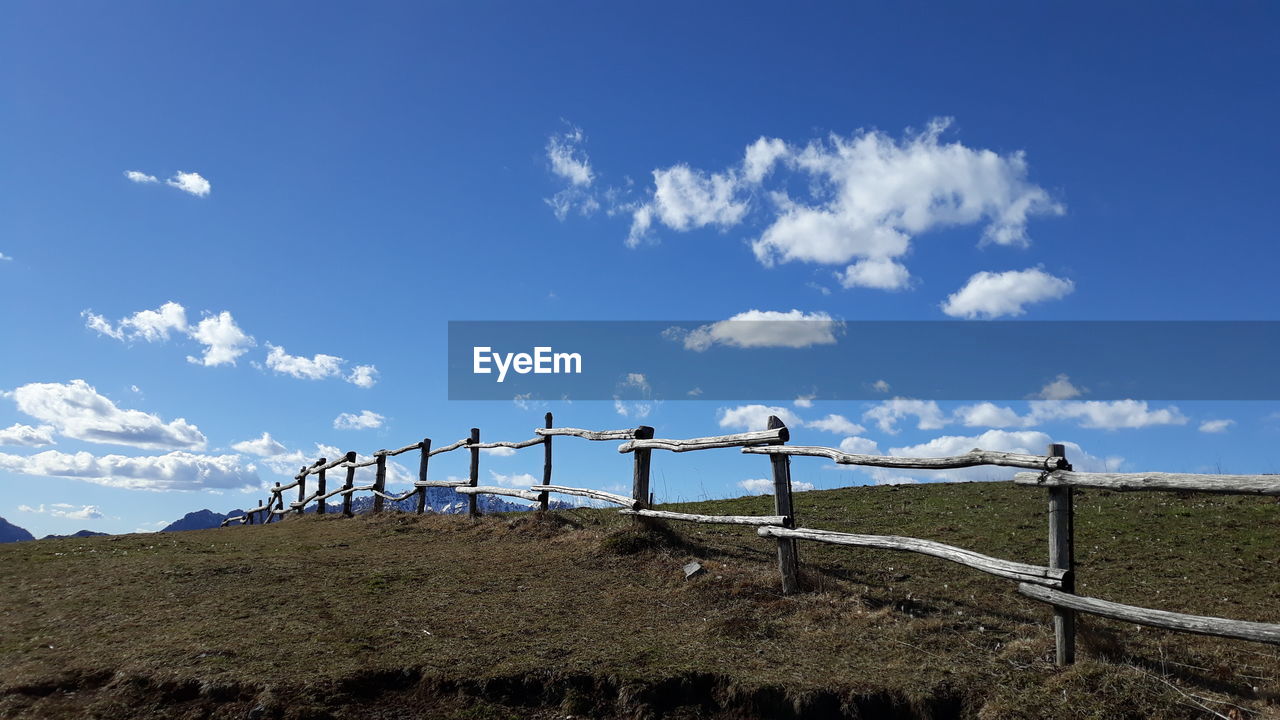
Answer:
[[627, 119, 1064, 288]]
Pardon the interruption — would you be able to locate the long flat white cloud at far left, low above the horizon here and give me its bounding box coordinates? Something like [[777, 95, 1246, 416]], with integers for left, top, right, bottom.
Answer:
[[0, 450, 259, 491]]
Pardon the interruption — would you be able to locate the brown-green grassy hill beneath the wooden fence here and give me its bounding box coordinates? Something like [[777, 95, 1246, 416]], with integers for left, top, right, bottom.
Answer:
[[0, 483, 1280, 720]]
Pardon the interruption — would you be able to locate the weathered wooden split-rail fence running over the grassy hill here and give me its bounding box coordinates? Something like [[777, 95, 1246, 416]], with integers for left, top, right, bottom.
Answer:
[[223, 413, 1280, 665]]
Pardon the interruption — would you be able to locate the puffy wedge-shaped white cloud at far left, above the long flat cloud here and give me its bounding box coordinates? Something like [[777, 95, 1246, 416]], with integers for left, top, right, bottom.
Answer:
[[13, 379, 206, 450]]
